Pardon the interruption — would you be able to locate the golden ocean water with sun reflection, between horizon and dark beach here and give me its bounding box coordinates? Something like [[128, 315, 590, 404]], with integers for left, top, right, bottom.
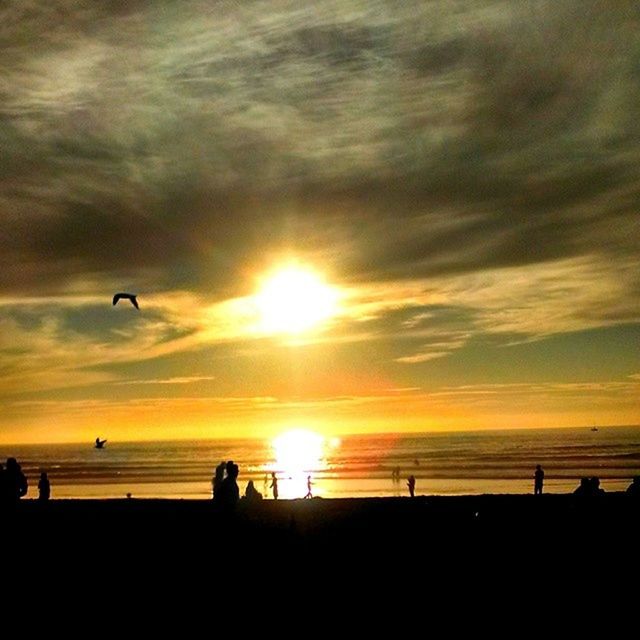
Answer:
[[0, 426, 640, 499]]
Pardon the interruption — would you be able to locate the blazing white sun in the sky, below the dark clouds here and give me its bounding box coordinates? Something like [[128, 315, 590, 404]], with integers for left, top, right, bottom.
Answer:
[[254, 265, 339, 335]]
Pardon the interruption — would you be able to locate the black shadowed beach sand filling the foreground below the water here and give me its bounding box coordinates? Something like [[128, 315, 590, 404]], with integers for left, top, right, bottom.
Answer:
[[7, 493, 640, 612]]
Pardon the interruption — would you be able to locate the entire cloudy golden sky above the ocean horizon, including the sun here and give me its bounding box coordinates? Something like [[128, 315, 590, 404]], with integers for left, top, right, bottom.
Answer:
[[0, 0, 640, 442]]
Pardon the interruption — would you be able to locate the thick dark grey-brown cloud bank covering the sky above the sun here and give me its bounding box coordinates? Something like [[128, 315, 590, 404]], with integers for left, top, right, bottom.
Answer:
[[0, 0, 640, 296]]
